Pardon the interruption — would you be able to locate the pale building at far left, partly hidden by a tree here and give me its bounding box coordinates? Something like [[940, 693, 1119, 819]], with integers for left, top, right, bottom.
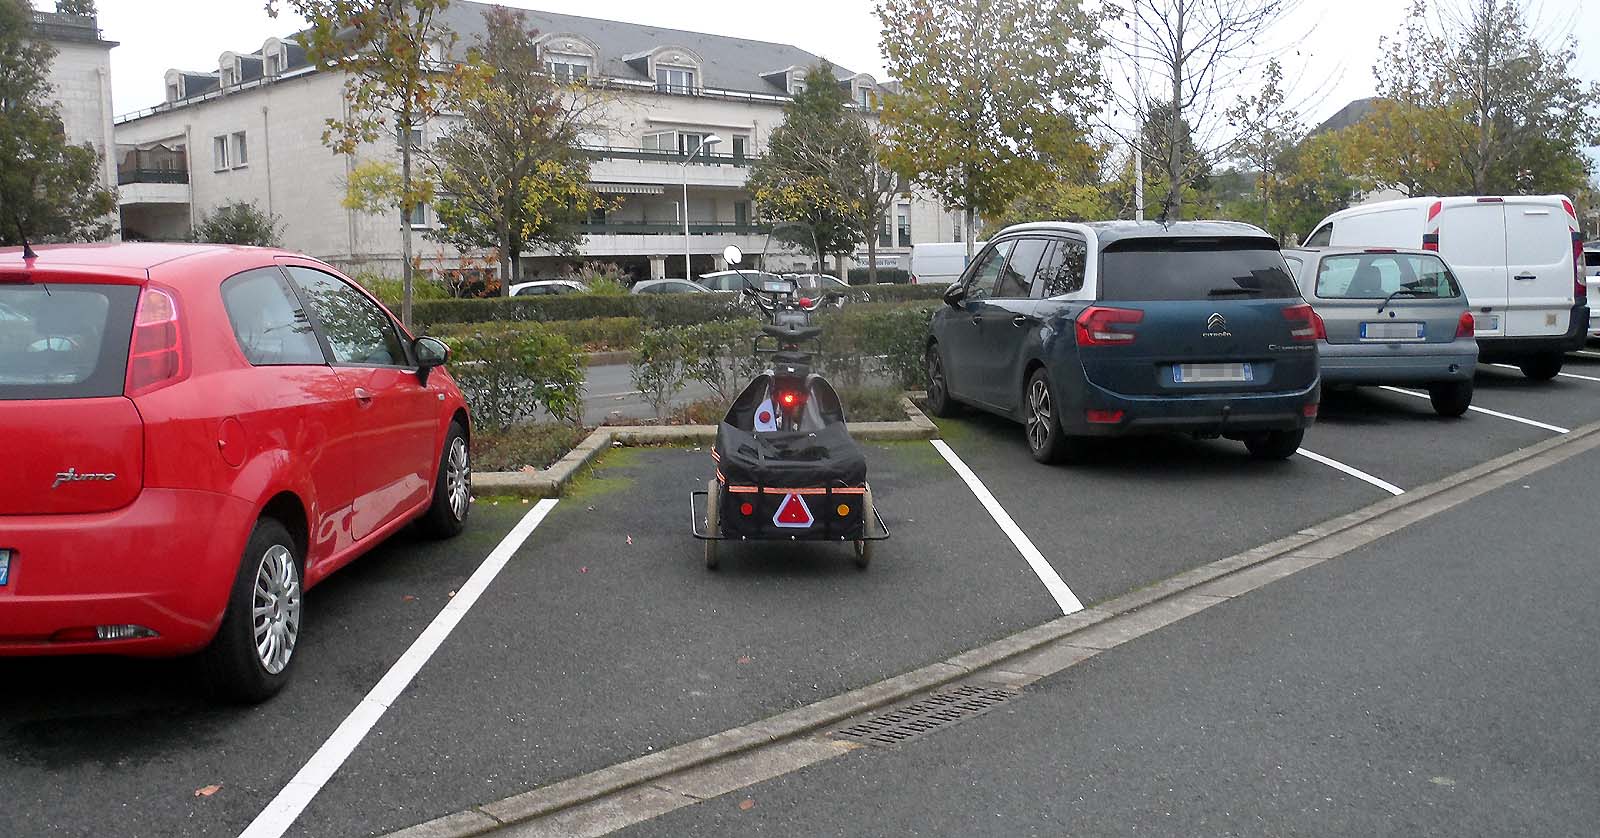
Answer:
[[34, 10, 117, 237]]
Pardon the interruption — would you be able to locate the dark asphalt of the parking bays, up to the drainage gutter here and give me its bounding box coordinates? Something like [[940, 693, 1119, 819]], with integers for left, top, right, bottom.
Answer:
[[0, 355, 1600, 836]]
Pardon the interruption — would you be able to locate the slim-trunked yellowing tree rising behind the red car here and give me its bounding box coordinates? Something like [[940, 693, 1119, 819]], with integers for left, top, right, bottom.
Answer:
[[267, 0, 461, 328]]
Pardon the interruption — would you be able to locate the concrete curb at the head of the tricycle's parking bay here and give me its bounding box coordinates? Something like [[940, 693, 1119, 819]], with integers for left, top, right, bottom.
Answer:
[[472, 397, 939, 497]]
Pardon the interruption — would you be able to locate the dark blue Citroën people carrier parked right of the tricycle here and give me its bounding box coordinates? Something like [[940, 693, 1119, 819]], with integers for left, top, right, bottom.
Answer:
[[926, 221, 1325, 462]]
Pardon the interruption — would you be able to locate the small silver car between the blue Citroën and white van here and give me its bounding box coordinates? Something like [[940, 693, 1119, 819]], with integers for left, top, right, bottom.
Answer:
[[1283, 248, 1478, 416]]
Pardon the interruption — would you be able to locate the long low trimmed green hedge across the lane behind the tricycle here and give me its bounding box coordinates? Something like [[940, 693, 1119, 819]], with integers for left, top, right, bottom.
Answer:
[[413, 285, 944, 328]]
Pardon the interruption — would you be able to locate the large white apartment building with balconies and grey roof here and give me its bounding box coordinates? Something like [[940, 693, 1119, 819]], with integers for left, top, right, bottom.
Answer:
[[117, 2, 960, 278]]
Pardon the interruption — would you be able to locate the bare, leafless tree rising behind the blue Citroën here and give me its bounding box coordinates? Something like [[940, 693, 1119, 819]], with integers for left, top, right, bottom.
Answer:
[[1106, 0, 1299, 219]]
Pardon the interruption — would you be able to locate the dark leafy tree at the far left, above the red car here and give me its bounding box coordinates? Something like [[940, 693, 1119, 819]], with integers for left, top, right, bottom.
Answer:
[[0, 0, 117, 245]]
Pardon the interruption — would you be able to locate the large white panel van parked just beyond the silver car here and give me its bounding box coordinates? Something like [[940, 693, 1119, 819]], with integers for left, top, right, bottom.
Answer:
[[1306, 195, 1589, 381]]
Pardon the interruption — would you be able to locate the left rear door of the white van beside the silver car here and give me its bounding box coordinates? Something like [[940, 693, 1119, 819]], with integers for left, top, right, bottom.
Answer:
[[1433, 200, 1504, 337]]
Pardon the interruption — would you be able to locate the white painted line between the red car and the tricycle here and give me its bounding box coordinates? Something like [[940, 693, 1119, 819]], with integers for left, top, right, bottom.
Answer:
[[240, 499, 555, 838]]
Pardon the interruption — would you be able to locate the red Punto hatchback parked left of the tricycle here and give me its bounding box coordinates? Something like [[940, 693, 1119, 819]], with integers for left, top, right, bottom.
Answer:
[[0, 245, 472, 700]]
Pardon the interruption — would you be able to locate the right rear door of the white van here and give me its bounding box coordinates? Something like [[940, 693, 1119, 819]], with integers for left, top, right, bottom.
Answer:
[[1502, 198, 1574, 336]]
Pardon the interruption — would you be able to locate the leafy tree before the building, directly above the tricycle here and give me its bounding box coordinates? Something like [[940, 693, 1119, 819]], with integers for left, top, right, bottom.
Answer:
[[749, 62, 872, 270]]
